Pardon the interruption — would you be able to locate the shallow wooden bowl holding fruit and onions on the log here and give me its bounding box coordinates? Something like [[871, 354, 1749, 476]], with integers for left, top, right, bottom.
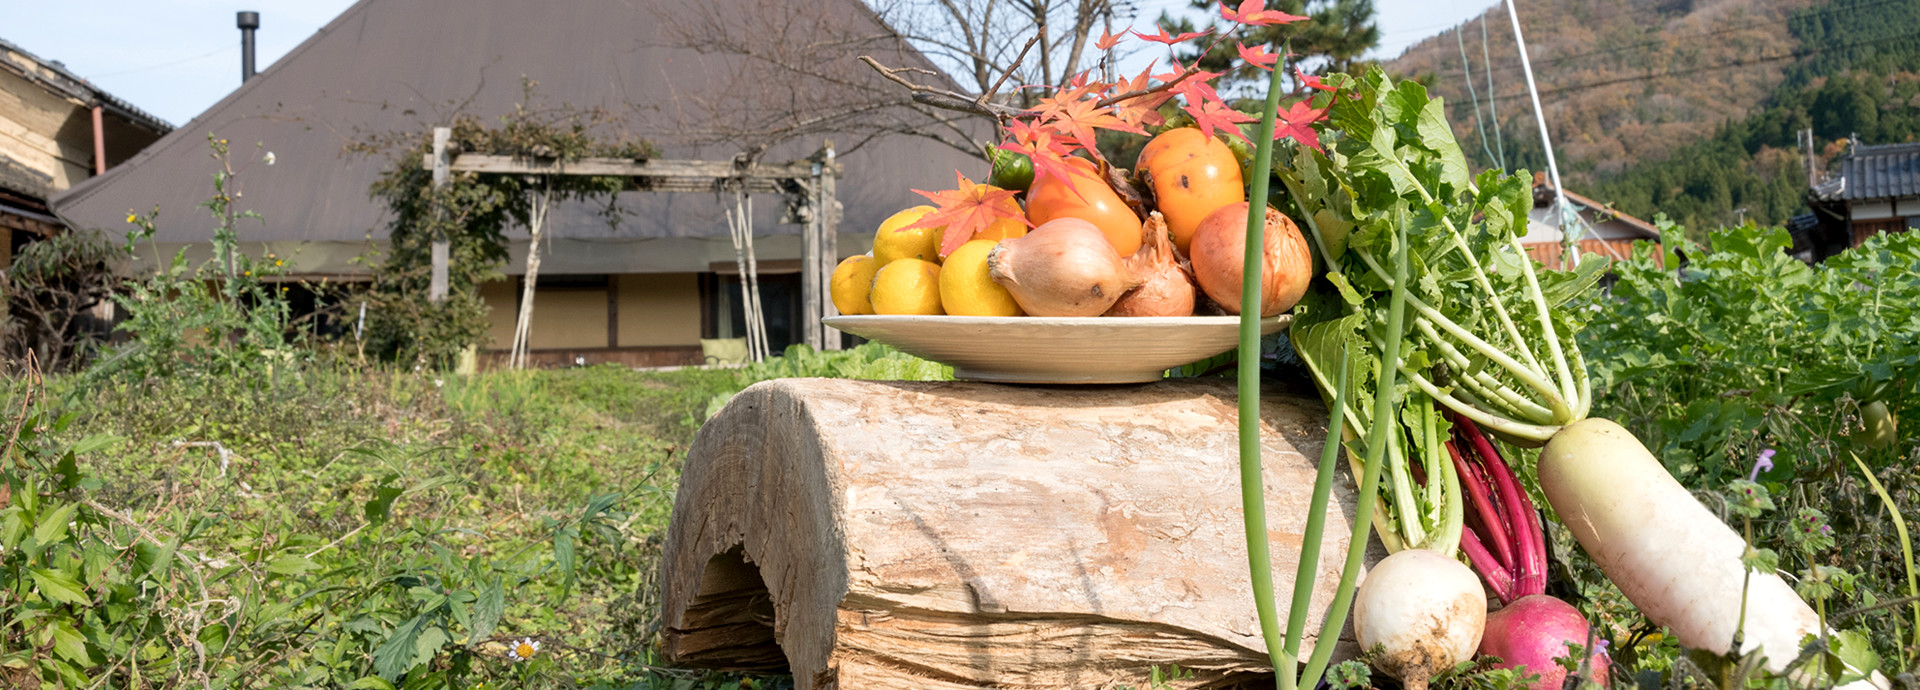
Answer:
[[824, 313, 1292, 384]]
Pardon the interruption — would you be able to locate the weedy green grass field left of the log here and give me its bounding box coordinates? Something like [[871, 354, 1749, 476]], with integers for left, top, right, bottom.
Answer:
[[0, 346, 948, 688]]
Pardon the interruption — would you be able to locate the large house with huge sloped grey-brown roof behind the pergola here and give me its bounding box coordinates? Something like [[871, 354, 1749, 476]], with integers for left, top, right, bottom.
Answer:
[[52, 0, 987, 365]]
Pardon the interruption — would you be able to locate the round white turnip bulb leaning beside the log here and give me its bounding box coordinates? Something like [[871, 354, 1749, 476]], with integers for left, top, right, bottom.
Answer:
[[1354, 548, 1486, 690]]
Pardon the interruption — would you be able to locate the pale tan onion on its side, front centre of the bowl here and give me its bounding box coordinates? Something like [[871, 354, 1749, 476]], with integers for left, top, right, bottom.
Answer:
[[987, 217, 1140, 317]]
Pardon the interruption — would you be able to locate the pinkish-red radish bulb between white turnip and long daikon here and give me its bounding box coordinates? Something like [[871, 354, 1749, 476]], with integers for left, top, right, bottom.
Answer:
[[1480, 594, 1611, 690]]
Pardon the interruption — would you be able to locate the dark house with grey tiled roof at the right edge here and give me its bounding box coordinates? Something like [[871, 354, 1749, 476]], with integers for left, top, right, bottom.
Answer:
[[1789, 140, 1920, 261]]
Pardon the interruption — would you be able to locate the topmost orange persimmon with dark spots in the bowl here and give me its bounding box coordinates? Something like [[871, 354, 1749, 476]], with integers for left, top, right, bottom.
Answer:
[[1137, 127, 1246, 252]]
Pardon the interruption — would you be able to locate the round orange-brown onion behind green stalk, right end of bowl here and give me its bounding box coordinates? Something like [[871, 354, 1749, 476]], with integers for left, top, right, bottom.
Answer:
[[1190, 204, 1313, 317]]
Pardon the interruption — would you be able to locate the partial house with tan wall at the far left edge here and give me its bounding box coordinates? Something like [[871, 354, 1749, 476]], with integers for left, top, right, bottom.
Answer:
[[0, 40, 173, 269]]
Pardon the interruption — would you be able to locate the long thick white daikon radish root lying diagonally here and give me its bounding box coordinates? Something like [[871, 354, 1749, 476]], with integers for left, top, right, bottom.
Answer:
[[1540, 417, 1887, 688]]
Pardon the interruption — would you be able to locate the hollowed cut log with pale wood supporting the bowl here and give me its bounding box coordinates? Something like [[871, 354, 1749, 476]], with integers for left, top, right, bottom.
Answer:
[[662, 379, 1384, 690]]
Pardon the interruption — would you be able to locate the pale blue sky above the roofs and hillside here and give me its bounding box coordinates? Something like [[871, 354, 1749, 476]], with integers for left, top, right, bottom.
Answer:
[[0, 0, 1494, 125]]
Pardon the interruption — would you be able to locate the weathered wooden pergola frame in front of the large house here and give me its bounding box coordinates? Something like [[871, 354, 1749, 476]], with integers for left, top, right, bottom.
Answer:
[[426, 127, 841, 365]]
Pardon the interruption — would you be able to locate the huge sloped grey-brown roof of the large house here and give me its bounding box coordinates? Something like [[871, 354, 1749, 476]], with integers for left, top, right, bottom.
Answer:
[[52, 0, 985, 242]]
